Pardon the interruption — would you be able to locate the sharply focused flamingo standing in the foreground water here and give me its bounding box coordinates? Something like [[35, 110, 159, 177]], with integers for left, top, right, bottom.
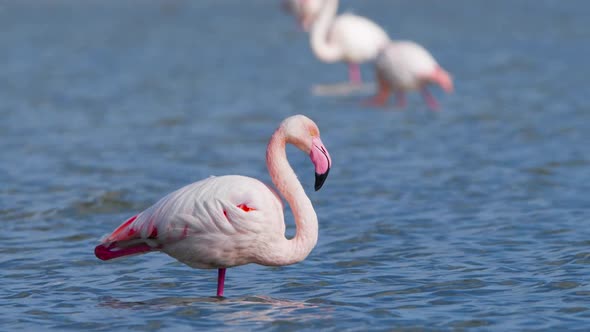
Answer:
[[94, 115, 332, 297]]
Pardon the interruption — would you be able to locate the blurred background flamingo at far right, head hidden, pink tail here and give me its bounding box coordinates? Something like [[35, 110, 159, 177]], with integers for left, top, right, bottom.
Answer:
[[369, 41, 453, 111]]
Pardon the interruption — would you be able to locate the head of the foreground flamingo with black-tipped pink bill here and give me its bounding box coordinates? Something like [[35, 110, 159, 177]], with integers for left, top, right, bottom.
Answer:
[[282, 115, 332, 191]]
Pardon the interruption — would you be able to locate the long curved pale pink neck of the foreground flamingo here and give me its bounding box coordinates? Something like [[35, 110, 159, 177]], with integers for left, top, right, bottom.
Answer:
[[261, 127, 318, 265]]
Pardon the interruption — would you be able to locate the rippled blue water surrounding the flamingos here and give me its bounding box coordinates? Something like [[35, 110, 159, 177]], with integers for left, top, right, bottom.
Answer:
[[0, 0, 590, 331]]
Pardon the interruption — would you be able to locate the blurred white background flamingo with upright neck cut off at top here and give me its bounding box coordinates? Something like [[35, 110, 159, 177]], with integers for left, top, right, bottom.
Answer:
[[310, 0, 390, 84]]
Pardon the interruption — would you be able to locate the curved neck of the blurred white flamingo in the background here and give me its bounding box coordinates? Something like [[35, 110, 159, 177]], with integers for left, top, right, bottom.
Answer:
[[310, 0, 342, 62]]
